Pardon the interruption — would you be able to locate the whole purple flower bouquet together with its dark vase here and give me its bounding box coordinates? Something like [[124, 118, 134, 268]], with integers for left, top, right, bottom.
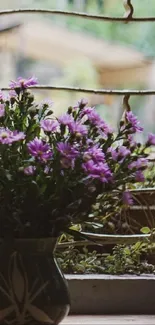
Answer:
[[0, 78, 155, 324]]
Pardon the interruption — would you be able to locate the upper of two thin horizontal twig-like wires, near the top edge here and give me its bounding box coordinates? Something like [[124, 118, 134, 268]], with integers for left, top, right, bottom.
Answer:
[[0, 8, 155, 23]]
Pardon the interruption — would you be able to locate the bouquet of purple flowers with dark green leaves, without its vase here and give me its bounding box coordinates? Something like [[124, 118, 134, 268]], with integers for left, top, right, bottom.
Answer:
[[0, 78, 155, 237]]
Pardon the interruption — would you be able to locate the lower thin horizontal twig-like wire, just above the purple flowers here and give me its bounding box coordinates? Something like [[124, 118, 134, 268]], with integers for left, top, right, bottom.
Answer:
[[1, 85, 155, 96]]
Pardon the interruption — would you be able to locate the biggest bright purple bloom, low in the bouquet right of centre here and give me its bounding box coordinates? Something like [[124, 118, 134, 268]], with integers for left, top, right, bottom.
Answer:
[[82, 160, 112, 183]]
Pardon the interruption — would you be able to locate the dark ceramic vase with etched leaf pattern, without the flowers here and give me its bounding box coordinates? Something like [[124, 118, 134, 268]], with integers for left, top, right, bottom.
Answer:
[[0, 238, 70, 325]]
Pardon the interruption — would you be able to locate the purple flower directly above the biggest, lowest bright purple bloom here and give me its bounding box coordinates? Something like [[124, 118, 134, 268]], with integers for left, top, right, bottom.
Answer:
[[83, 145, 105, 162]]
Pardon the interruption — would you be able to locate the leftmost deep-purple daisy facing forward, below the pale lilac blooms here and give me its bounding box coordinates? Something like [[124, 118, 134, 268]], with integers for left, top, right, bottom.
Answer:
[[27, 137, 53, 162]]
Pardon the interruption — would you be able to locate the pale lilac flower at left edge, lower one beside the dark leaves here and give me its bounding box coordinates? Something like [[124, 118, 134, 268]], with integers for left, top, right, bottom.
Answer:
[[0, 127, 25, 144]]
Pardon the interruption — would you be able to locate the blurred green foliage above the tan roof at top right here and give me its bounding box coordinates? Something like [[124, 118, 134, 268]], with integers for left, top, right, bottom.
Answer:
[[29, 0, 155, 57]]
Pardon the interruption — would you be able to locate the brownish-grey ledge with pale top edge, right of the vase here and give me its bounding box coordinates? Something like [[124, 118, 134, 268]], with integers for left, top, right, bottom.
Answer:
[[66, 275, 155, 315]]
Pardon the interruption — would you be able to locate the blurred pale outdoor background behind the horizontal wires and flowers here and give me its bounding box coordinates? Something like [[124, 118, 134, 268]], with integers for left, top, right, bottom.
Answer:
[[0, 0, 155, 132]]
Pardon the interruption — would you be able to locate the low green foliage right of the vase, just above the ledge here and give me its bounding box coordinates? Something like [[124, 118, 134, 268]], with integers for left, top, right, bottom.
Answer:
[[56, 242, 155, 275]]
